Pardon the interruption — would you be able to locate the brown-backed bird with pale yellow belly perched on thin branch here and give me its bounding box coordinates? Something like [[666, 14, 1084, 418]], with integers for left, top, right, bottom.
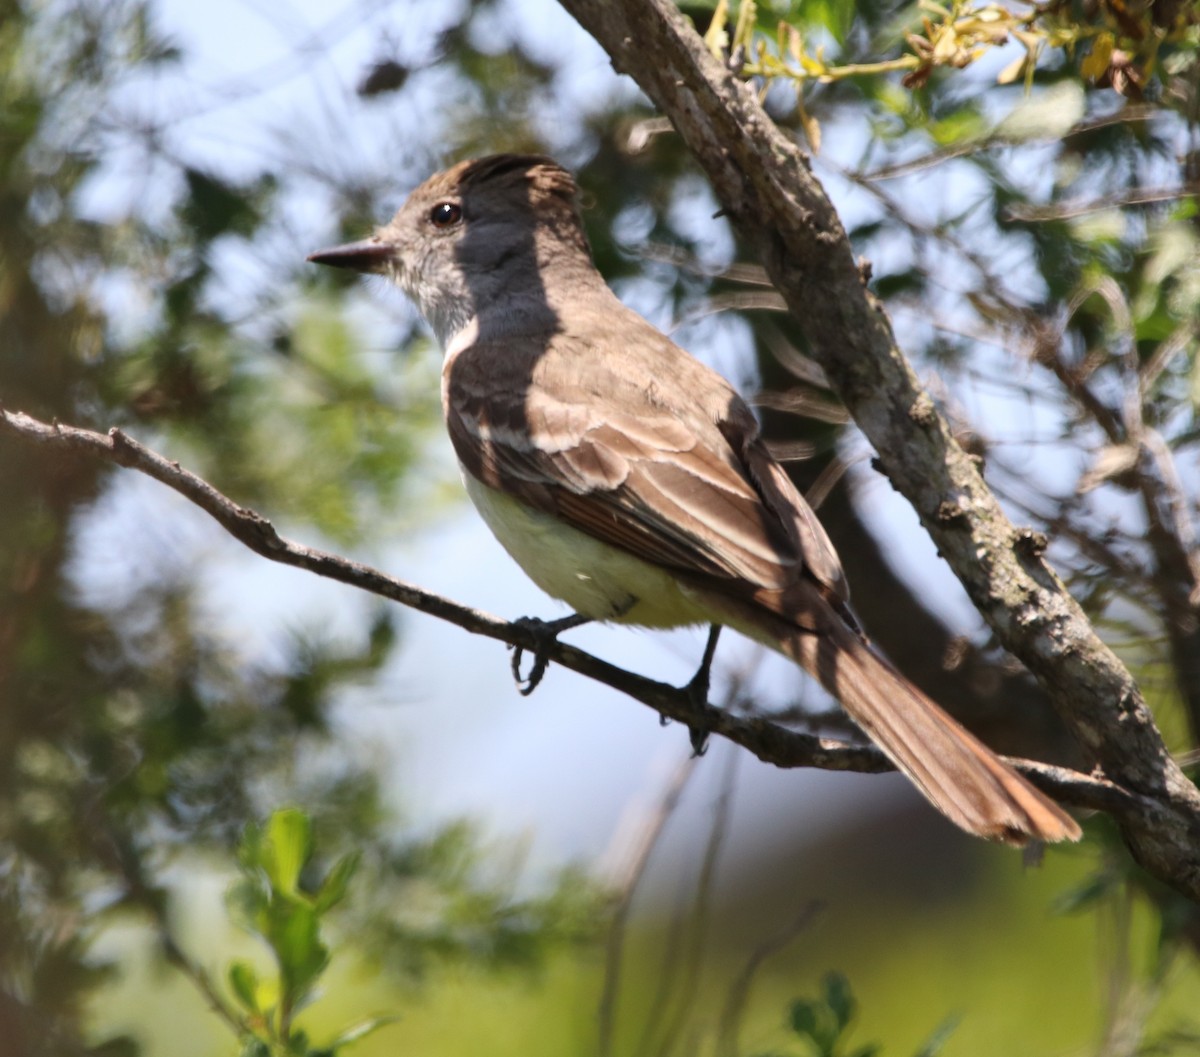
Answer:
[[308, 154, 1081, 845]]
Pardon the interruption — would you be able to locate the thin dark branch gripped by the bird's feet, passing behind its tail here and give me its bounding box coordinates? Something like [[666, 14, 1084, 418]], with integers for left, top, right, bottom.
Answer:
[[0, 407, 1137, 823]]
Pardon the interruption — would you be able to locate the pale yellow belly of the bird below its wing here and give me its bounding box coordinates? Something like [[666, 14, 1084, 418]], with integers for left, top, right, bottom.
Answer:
[[462, 472, 714, 627]]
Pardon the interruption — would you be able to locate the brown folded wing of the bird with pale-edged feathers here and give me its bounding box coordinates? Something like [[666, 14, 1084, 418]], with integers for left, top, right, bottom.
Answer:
[[443, 324, 844, 597]]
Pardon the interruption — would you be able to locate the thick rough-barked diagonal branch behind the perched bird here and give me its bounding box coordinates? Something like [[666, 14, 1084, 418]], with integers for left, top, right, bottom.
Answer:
[[560, 0, 1200, 897]]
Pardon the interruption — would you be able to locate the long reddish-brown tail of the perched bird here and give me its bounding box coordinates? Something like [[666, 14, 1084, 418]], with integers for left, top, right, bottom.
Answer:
[[696, 585, 1081, 845]]
